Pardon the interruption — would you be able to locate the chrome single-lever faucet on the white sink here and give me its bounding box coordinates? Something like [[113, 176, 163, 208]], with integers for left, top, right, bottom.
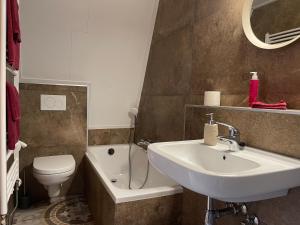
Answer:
[[216, 122, 245, 151]]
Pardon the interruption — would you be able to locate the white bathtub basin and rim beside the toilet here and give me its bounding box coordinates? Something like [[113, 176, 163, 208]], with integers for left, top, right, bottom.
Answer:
[[86, 145, 182, 203]]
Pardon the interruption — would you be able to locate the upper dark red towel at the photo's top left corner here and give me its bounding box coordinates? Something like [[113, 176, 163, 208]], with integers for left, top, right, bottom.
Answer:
[[6, 0, 21, 70]]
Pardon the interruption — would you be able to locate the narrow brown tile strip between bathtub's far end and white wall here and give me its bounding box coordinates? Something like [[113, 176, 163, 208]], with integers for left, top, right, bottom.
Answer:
[[88, 128, 133, 145]]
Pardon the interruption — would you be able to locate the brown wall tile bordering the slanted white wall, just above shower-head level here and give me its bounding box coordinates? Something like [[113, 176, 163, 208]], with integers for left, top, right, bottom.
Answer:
[[143, 26, 192, 95]]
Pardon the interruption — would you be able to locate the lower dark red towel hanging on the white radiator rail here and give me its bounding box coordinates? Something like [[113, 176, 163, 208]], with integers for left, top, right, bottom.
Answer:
[[6, 82, 21, 150]]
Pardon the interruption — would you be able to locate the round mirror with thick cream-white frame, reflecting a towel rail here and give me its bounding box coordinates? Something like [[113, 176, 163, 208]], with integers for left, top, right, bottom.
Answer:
[[243, 0, 300, 49]]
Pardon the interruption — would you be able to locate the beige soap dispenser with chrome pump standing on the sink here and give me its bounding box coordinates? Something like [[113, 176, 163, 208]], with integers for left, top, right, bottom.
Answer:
[[204, 113, 219, 146]]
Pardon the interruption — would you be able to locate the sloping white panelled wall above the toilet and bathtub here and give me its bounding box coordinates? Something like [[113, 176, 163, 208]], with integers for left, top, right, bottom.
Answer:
[[21, 0, 159, 128]]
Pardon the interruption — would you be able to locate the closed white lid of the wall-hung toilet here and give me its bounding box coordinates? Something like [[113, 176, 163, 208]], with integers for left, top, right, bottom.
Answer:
[[33, 155, 75, 175]]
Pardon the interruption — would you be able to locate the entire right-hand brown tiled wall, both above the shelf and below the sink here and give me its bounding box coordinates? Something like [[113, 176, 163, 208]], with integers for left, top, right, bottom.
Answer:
[[137, 0, 300, 225]]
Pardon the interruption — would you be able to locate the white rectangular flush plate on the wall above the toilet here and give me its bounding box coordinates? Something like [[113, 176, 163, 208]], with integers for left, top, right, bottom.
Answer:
[[41, 95, 67, 111]]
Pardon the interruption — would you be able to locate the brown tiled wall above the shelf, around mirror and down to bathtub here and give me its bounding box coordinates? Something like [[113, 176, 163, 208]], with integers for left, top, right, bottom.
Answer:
[[138, 0, 300, 144]]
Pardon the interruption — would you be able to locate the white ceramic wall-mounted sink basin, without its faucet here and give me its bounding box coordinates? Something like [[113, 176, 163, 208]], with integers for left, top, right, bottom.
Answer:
[[148, 140, 300, 202]]
